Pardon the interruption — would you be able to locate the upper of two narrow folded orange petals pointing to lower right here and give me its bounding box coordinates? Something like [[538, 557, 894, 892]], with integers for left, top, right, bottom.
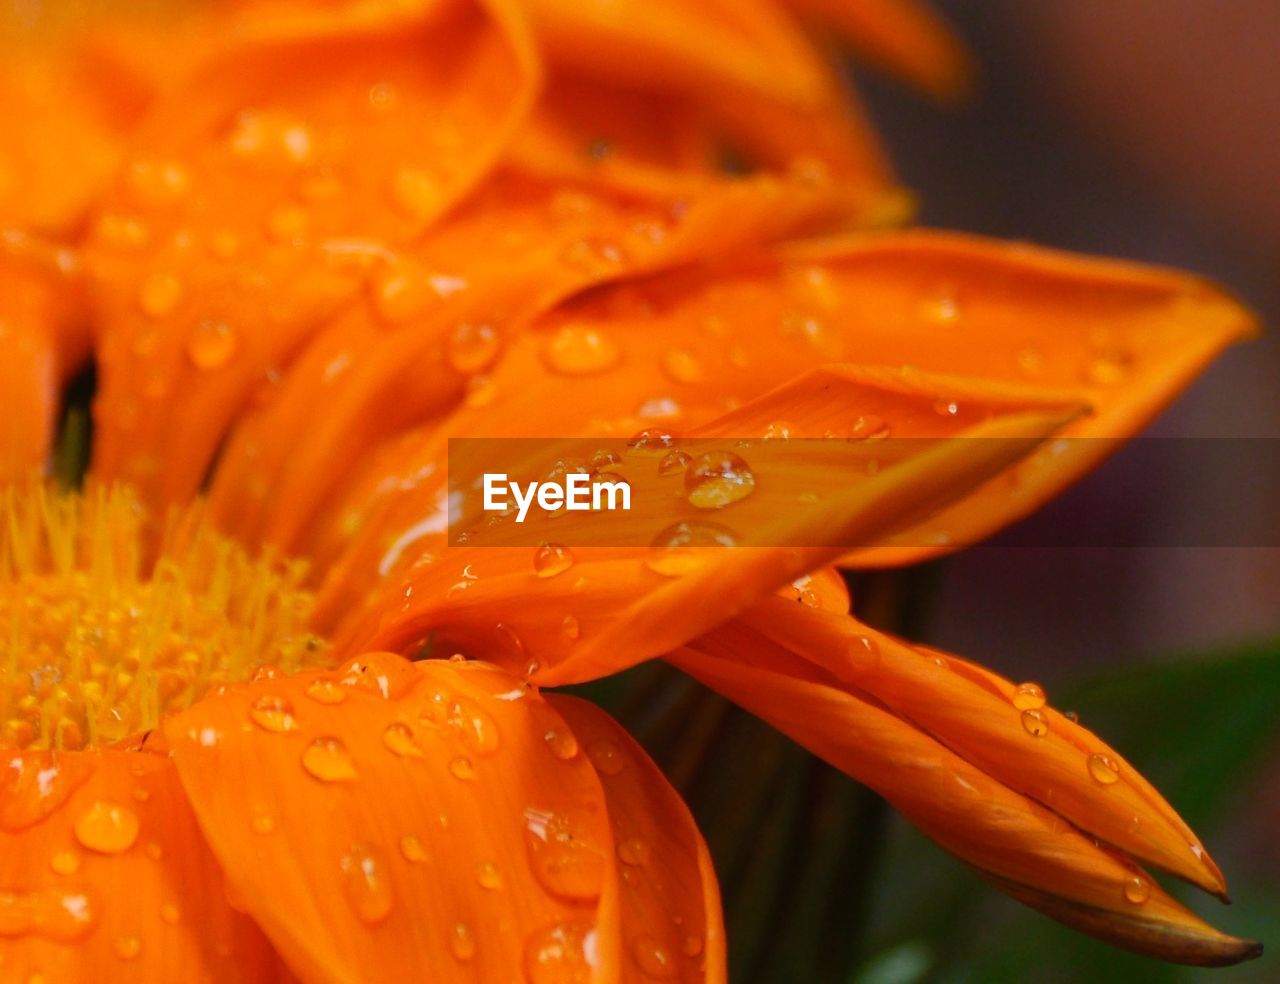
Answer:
[[712, 600, 1226, 896]]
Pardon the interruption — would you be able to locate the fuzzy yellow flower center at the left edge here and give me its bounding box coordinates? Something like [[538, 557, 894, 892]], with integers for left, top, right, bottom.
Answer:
[[0, 481, 328, 749]]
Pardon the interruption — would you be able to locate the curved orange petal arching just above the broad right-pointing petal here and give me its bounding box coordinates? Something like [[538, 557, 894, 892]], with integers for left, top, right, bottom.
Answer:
[[211, 168, 877, 550]]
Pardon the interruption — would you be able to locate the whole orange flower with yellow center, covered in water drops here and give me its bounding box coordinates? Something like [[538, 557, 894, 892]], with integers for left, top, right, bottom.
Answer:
[[0, 0, 1257, 981]]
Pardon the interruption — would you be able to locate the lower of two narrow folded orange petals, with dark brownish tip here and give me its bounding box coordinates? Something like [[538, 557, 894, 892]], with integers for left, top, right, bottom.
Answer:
[[669, 624, 1261, 965]]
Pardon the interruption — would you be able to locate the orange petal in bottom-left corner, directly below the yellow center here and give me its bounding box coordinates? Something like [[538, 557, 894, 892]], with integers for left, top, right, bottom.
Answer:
[[0, 750, 282, 984]]
